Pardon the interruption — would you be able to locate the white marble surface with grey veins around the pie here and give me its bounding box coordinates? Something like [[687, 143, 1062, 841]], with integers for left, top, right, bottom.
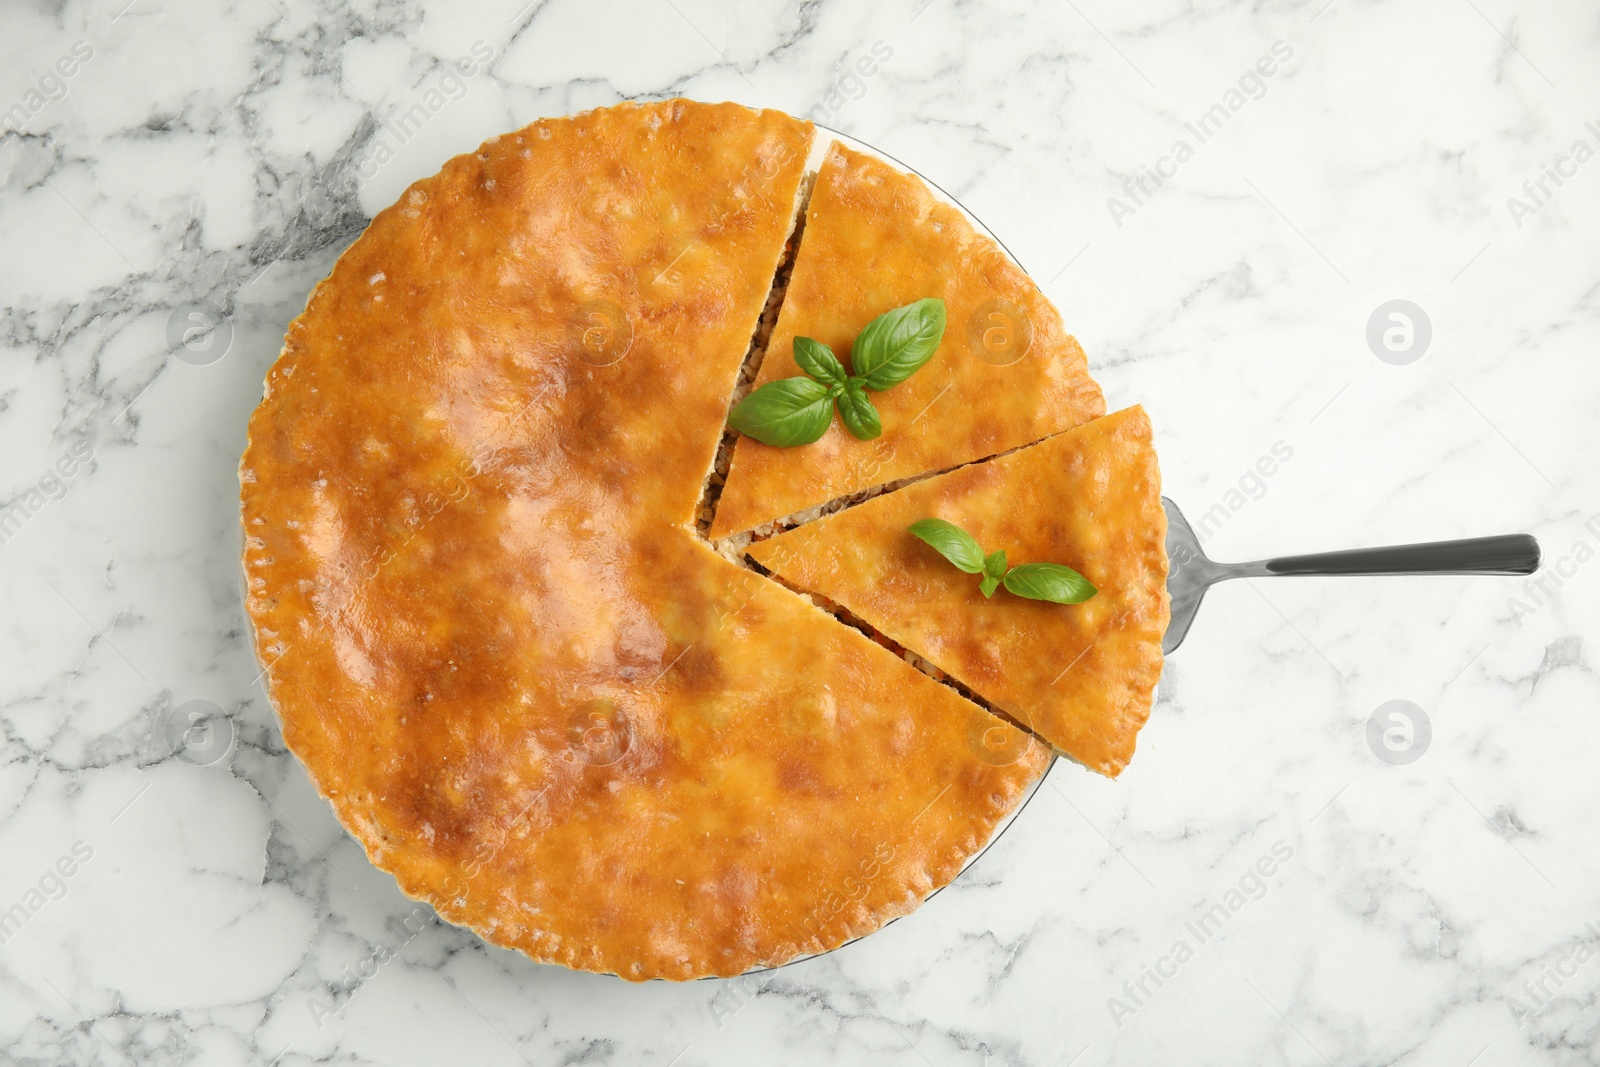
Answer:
[[0, 0, 1600, 1067]]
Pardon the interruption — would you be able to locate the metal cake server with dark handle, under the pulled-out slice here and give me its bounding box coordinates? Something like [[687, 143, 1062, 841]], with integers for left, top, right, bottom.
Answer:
[[1162, 496, 1539, 653]]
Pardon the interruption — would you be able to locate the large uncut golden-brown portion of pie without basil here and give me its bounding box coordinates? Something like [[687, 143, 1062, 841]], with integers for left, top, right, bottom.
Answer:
[[240, 101, 1050, 979]]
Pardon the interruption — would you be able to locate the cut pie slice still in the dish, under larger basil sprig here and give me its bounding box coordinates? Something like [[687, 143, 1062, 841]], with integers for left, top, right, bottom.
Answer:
[[710, 144, 1106, 539]]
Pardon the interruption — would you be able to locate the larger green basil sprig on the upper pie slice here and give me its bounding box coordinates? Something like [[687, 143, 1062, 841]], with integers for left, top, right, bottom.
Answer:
[[728, 298, 944, 448]]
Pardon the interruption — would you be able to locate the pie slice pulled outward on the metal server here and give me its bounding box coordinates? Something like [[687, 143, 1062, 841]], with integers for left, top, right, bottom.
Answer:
[[749, 406, 1170, 777]]
